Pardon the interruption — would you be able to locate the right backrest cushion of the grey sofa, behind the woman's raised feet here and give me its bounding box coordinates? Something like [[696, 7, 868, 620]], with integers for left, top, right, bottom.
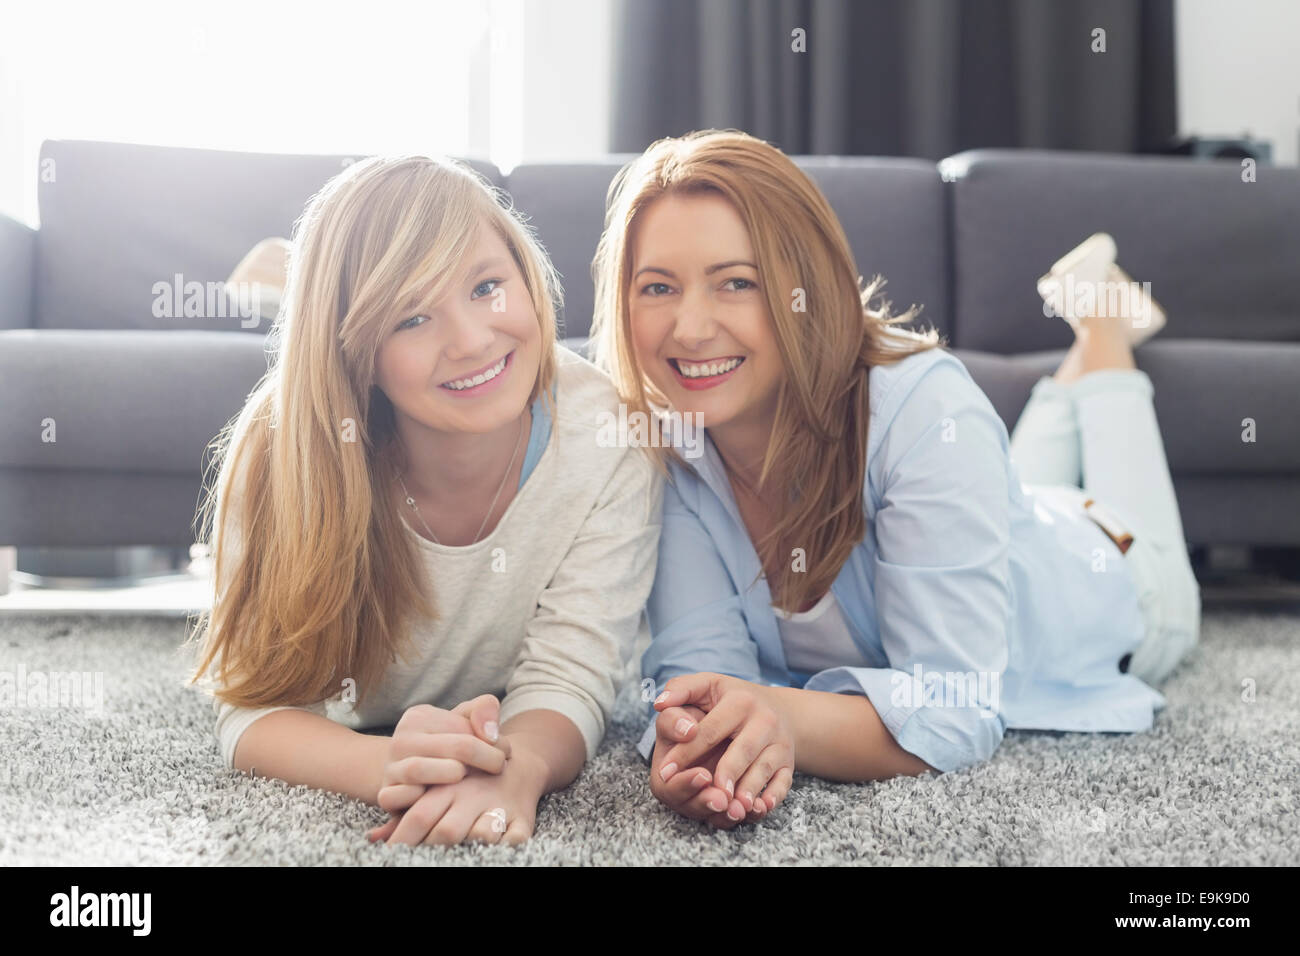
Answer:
[[939, 150, 1300, 354]]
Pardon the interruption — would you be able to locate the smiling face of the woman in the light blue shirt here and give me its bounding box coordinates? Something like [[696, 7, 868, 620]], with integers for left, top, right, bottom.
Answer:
[[628, 193, 784, 428]]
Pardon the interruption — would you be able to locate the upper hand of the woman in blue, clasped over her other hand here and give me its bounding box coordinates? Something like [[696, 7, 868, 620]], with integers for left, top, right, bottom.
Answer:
[[654, 674, 794, 822]]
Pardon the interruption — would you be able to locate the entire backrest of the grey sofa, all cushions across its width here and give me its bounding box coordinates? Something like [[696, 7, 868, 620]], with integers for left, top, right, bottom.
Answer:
[[34, 140, 1300, 354]]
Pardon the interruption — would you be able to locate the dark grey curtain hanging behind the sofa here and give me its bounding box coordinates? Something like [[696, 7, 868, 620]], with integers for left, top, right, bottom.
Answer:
[[610, 0, 1177, 160]]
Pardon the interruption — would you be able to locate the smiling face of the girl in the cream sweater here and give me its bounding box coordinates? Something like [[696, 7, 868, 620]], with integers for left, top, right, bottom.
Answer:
[[376, 225, 542, 433]]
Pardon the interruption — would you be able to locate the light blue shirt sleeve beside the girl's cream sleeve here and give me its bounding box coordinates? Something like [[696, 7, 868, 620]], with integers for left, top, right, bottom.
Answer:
[[637, 476, 762, 760]]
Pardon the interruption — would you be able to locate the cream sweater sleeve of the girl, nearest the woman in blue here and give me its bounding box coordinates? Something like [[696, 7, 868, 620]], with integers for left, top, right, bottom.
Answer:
[[499, 449, 663, 760]]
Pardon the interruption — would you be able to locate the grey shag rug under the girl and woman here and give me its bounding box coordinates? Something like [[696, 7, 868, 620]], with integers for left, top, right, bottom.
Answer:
[[0, 610, 1300, 866]]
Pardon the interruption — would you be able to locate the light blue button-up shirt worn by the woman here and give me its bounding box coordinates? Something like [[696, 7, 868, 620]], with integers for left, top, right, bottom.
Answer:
[[637, 329, 1165, 771]]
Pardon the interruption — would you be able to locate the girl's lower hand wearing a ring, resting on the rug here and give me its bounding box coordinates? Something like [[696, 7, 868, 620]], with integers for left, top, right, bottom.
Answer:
[[367, 749, 546, 845]]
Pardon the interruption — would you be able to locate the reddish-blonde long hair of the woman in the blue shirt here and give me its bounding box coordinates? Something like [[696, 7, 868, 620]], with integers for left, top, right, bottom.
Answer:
[[592, 130, 945, 611]]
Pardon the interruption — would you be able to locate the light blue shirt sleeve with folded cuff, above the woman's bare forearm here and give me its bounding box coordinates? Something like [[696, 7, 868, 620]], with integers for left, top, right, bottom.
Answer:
[[805, 363, 1011, 771]]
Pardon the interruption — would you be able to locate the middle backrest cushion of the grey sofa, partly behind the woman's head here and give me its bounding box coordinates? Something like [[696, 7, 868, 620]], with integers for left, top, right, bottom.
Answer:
[[506, 155, 952, 348]]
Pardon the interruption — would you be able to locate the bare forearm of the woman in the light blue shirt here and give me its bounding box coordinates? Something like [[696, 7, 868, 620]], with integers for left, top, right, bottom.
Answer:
[[761, 687, 937, 782]]
